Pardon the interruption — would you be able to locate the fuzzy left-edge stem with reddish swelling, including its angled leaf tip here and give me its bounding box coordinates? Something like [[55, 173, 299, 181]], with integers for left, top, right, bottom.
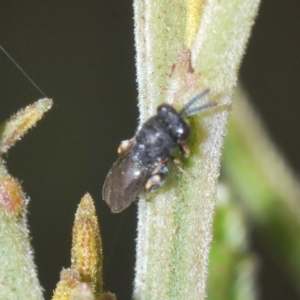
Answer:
[[0, 98, 52, 300]]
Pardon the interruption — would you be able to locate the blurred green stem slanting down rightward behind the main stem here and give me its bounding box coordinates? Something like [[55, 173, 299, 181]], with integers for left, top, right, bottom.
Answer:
[[223, 88, 300, 291]]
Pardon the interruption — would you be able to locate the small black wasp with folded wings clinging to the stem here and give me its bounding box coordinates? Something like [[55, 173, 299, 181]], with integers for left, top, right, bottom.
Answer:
[[102, 89, 216, 213]]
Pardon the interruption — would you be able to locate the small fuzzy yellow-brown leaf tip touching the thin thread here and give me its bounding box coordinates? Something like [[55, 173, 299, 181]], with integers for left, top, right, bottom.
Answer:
[[0, 98, 52, 154]]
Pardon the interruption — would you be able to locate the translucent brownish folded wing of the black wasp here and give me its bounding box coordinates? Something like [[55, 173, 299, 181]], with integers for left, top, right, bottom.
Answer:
[[102, 150, 149, 213]]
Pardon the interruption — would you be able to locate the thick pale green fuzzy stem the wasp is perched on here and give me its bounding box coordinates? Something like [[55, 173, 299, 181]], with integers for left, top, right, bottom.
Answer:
[[134, 0, 259, 299]]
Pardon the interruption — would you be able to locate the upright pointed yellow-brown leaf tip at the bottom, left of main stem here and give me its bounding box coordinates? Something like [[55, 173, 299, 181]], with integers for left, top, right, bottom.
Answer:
[[52, 194, 113, 300]]
